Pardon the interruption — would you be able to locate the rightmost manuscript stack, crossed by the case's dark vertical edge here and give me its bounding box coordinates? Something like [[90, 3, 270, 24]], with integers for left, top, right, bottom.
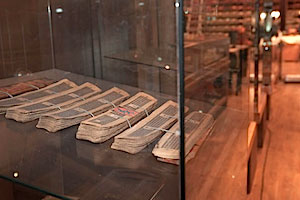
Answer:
[[152, 112, 214, 160]]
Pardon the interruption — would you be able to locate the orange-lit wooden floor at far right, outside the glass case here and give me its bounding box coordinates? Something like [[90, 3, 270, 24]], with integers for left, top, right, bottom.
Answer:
[[247, 63, 300, 200]]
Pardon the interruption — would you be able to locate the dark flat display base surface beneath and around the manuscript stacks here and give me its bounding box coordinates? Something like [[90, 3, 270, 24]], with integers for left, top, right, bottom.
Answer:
[[0, 70, 179, 199]]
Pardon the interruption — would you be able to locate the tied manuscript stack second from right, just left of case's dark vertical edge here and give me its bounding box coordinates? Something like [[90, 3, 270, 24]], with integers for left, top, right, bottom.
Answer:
[[111, 101, 178, 154]]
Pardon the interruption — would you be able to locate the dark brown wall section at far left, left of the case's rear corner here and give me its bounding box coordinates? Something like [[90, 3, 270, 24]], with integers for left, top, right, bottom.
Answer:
[[0, 0, 52, 78]]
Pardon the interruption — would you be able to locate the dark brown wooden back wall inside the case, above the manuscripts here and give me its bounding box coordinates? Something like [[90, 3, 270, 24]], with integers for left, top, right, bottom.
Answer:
[[0, 0, 176, 86]]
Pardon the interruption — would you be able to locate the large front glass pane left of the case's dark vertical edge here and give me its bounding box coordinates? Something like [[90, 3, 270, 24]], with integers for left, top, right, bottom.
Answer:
[[0, 0, 179, 200]]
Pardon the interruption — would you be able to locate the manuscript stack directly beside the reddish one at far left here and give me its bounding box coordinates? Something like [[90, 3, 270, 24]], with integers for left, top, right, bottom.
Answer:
[[0, 79, 77, 113]]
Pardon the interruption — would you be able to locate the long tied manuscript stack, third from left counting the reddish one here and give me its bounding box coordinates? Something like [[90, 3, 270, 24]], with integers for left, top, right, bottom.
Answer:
[[5, 83, 101, 122]]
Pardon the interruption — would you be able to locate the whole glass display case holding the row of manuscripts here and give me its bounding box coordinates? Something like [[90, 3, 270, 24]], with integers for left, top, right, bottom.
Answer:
[[0, 0, 250, 200]]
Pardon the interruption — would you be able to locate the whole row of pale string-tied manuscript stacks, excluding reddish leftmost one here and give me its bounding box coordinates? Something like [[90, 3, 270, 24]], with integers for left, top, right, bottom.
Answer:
[[0, 79, 214, 163]]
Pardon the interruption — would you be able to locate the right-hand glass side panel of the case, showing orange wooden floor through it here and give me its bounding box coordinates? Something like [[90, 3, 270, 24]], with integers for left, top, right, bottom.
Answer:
[[184, 0, 254, 199]]
